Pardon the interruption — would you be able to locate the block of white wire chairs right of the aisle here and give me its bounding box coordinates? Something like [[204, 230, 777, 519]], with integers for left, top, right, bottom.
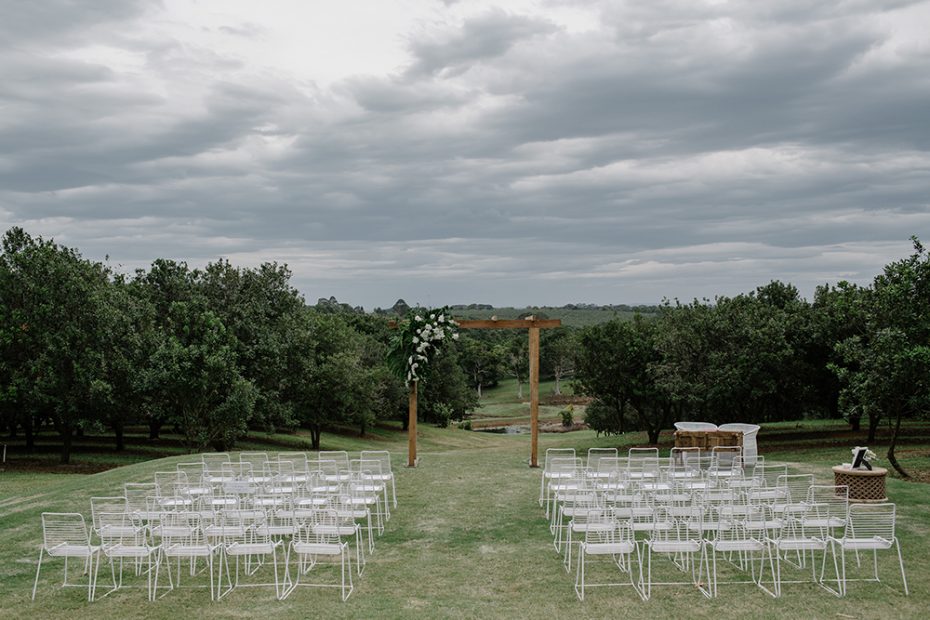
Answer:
[[543, 451, 908, 599]]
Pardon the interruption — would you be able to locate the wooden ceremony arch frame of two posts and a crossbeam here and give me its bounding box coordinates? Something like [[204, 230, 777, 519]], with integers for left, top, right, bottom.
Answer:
[[398, 316, 562, 467]]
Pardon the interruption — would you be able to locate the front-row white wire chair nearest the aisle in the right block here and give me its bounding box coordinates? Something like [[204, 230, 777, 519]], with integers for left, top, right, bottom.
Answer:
[[575, 512, 645, 601]]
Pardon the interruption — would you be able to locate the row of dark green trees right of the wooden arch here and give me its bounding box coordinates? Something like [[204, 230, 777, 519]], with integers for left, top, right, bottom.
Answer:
[[576, 238, 930, 475]]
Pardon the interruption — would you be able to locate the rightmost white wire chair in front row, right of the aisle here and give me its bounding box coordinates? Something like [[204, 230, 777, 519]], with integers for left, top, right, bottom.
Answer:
[[829, 502, 909, 596]]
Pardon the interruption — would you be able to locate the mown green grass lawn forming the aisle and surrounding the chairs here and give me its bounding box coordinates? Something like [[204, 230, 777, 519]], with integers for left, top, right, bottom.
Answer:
[[0, 422, 930, 619]]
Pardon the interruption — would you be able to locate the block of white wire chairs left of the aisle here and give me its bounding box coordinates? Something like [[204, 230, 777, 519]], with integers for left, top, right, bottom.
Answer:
[[32, 451, 397, 601]]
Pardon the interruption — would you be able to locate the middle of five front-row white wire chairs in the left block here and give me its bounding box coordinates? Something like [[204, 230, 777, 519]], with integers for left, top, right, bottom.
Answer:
[[152, 512, 220, 600]]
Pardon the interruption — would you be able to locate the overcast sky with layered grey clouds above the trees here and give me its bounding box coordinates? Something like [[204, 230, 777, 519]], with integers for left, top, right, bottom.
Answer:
[[0, 0, 930, 309]]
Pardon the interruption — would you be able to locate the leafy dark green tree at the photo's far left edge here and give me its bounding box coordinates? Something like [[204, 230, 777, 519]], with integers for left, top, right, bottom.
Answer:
[[0, 228, 109, 464]]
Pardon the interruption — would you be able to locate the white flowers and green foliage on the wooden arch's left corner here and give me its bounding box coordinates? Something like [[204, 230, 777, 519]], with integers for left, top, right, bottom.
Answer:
[[390, 308, 459, 386]]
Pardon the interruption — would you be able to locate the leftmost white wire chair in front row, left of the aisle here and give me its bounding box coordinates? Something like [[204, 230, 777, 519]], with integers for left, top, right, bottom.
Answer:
[[32, 512, 100, 601]]
